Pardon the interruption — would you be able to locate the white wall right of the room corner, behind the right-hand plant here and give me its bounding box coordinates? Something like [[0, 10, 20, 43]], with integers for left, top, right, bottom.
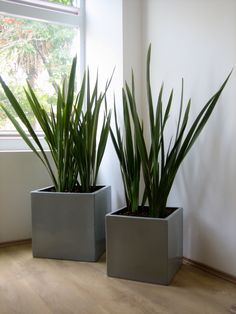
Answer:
[[143, 0, 236, 276]]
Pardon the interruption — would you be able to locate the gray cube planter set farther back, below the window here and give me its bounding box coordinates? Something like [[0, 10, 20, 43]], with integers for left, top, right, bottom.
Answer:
[[31, 187, 111, 261]]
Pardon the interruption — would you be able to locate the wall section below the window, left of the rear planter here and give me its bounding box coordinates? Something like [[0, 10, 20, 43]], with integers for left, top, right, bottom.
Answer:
[[0, 152, 51, 243]]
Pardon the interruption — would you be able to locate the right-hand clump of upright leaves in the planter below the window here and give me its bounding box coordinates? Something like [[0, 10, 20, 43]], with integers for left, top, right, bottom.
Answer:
[[71, 69, 111, 192]]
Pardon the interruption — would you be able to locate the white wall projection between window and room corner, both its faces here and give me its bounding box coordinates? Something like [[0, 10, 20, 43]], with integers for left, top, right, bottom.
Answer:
[[86, 0, 142, 210]]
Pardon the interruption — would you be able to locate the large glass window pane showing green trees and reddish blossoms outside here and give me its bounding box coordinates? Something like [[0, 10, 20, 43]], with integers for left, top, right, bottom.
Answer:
[[0, 15, 79, 132]]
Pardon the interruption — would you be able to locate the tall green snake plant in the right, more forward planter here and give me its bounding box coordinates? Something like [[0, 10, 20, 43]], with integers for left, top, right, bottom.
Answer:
[[111, 45, 231, 218]]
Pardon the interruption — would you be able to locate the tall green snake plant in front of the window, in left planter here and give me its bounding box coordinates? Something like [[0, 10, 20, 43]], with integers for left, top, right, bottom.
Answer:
[[0, 57, 110, 192]]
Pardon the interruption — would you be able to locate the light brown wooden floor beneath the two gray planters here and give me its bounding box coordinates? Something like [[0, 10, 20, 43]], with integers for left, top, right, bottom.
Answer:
[[0, 245, 236, 314]]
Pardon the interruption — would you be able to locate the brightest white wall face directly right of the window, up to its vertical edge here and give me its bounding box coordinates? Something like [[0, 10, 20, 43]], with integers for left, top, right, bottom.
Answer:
[[86, 0, 124, 210]]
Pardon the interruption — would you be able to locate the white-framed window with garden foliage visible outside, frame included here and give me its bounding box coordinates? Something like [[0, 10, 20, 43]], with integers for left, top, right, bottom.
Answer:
[[0, 0, 84, 149]]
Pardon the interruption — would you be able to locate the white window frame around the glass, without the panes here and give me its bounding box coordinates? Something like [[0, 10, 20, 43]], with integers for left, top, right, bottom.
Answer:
[[0, 0, 85, 152]]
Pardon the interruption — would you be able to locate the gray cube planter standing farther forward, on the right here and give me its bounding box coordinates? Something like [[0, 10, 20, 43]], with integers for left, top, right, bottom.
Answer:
[[106, 208, 183, 285]]
